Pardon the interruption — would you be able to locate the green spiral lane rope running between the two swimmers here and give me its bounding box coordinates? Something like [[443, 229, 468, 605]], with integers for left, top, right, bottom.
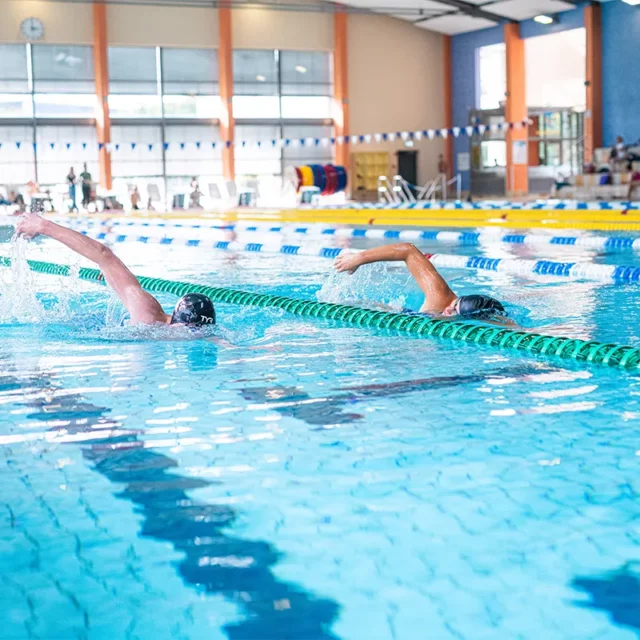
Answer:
[[0, 256, 640, 369]]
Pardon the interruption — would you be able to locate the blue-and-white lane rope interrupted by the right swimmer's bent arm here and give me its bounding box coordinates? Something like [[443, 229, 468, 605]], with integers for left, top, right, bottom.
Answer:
[[77, 231, 640, 284]]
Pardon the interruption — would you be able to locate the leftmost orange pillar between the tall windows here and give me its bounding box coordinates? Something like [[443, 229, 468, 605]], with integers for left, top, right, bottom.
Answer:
[[93, 3, 112, 189]]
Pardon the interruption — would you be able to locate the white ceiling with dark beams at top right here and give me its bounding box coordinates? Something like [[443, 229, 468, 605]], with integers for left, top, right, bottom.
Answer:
[[342, 0, 606, 35]]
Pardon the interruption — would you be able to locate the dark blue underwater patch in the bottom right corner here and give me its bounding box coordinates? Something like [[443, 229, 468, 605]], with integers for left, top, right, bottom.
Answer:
[[571, 562, 640, 637]]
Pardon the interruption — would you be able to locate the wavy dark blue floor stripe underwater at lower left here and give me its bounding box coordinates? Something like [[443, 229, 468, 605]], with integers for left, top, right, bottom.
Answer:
[[0, 357, 339, 640]]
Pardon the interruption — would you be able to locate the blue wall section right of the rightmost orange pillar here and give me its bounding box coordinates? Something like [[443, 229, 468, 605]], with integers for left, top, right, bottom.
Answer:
[[602, 2, 640, 145]]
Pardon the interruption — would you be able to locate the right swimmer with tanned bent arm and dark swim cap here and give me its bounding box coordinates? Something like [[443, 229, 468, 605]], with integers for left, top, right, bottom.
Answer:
[[335, 243, 510, 324]]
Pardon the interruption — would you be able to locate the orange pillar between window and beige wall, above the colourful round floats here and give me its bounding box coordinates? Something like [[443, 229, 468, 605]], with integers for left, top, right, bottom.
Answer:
[[333, 11, 349, 168]]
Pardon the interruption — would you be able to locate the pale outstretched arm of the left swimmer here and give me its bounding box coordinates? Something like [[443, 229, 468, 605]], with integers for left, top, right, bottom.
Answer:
[[16, 213, 170, 324]]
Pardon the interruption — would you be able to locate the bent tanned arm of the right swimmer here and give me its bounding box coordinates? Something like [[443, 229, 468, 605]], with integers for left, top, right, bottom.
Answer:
[[335, 242, 458, 313]]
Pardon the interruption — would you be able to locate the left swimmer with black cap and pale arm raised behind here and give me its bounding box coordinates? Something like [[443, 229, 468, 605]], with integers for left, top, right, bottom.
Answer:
[[16, 213, 216, 327]]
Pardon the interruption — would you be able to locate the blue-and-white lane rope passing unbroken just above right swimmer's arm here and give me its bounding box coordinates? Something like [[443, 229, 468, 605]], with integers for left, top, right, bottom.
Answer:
[[54, 218, 640, 251]]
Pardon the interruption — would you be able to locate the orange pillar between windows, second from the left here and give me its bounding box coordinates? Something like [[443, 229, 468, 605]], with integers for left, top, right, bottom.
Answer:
[[218, 5, 236, 180]]
